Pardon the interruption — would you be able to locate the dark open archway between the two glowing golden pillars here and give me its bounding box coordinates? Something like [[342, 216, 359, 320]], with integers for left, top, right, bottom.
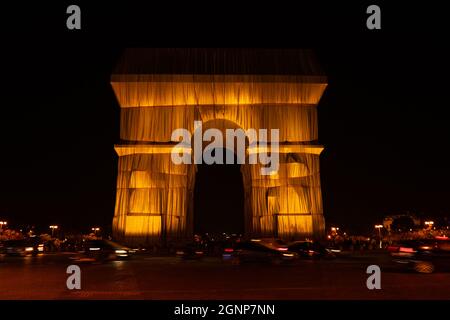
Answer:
[[194, 149, 244, 234]]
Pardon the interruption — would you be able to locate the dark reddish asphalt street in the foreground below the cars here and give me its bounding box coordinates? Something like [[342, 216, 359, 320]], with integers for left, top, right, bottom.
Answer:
[[0, 253, 450, 300]]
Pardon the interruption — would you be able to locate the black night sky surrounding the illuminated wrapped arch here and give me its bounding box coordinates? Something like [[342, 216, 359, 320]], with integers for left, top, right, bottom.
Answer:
[[0, 3, 450, 232]]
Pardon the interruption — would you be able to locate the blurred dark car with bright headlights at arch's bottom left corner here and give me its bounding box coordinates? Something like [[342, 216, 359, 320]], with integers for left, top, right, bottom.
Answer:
[[77, 240, 133, 262]]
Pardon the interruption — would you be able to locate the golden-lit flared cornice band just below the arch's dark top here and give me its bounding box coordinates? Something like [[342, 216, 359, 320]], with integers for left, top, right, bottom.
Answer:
[[111, 75, 327, 108]]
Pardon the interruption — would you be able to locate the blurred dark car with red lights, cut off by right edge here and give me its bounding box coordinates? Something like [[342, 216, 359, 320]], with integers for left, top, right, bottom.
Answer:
[[388, 237, 450, 273]]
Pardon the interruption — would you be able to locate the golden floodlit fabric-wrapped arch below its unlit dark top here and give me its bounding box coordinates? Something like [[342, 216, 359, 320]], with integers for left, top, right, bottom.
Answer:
[[111, 52, 327, 245]]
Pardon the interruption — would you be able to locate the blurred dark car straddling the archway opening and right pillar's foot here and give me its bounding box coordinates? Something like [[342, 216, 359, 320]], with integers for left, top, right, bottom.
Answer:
[[224, 240, 298, 264]]
